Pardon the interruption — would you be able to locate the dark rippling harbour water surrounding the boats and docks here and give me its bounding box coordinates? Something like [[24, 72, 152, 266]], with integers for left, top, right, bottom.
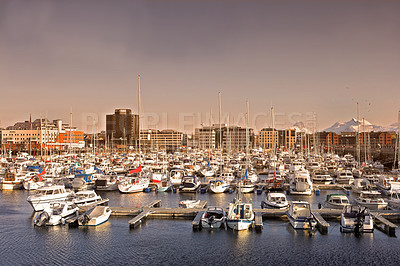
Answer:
[[0, 190, 400, 265]]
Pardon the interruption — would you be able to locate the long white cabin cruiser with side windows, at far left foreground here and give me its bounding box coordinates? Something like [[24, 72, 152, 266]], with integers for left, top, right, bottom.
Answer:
[[27, 185, 72, 211]]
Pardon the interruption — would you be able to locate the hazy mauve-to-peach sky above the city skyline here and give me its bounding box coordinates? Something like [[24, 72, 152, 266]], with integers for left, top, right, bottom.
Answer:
[[0, 0, 400, 131]]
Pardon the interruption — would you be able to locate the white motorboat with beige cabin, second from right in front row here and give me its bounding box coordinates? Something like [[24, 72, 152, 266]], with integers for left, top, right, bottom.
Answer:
[[286, 201, 317, 230]]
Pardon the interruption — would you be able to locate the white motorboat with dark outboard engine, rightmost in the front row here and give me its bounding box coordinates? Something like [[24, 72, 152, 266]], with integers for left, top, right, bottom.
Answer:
[[340, 205, 374, 233]]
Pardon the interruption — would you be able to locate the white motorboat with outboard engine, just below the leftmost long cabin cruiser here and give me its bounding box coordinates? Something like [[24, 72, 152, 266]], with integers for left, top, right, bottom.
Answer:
[[33, 201, 79, 226]]
